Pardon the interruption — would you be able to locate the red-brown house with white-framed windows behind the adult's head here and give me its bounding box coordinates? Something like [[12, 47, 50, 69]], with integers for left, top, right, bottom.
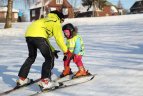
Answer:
[[30, 0, 74, 21]]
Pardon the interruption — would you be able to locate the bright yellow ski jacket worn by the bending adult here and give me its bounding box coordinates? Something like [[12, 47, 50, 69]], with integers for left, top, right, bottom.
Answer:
[[25, 13, 67, 53]]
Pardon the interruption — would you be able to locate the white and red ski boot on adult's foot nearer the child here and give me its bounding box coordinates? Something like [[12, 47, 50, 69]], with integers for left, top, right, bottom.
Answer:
[[38, 78, 59, 90]]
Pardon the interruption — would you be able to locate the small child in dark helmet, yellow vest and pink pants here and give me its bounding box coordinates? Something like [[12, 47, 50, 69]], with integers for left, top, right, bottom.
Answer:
[[60, 23, 89, 77]]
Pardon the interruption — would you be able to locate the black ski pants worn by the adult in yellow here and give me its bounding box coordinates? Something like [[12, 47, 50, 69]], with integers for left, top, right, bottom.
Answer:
[[18, 37, 54, 79]]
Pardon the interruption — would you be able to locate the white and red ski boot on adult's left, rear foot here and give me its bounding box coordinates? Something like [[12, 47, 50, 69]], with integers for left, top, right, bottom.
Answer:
[[16, 77, 33, 87]]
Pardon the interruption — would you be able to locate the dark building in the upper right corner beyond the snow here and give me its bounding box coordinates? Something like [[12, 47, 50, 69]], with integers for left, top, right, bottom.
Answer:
[[130, 0, 143, 14]]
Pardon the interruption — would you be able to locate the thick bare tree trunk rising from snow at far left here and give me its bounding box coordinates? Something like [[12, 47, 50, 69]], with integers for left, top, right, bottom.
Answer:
[[4, 0, 13, 28]]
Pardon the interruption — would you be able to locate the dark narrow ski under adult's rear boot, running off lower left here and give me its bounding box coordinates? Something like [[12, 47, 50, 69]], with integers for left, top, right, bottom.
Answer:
[[0, 78, 40, 96]]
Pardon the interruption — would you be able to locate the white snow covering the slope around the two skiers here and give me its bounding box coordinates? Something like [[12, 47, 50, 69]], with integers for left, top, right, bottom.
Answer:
[[0, 14, 143, 96]]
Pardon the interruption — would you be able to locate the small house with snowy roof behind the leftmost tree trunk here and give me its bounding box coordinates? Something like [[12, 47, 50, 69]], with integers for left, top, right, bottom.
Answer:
[[0, 7, 18, 22]]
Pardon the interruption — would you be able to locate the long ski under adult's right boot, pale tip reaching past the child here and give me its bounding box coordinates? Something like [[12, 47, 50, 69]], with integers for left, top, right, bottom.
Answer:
[[30, 74, 96, 96]]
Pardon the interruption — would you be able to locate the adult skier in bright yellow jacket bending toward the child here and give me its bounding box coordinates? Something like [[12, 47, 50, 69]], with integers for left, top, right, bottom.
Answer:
[[17, 11, 70, 89]]
